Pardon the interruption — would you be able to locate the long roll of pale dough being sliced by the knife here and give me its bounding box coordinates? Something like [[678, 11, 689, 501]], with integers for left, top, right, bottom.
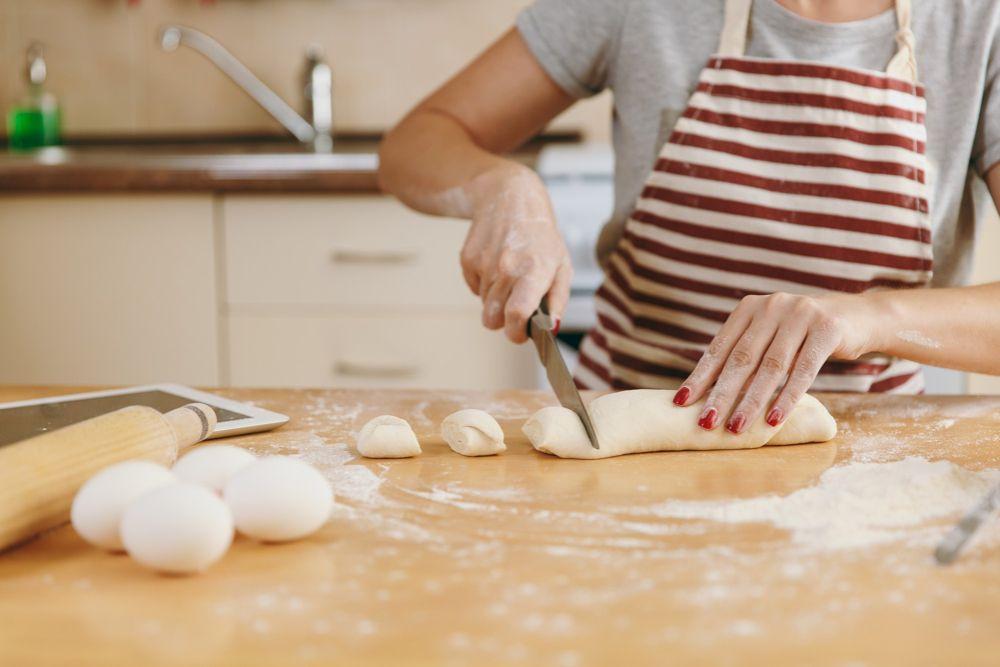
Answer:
[[523, 389, 837, 459]]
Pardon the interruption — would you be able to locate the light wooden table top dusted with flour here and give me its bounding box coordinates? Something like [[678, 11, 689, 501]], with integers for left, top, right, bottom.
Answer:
[[0, 388, 1000, 666]]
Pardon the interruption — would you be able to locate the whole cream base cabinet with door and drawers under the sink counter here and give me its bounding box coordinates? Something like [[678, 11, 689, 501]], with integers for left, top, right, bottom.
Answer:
[[0, 194, 537, 389]]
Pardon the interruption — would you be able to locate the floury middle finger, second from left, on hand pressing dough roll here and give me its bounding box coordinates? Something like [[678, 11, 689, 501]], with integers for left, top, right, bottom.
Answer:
[[698, 311, 779, 431]]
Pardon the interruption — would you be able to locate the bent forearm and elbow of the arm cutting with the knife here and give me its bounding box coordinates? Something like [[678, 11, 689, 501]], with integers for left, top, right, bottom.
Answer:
[[379, 109, 534, 218]]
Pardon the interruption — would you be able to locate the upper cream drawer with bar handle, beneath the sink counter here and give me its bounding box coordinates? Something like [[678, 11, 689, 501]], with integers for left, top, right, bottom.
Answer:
[[222, 195, 478, 309]]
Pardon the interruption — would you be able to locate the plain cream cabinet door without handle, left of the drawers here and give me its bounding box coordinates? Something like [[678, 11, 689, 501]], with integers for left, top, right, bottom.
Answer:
[[0, 195, 219, 385]]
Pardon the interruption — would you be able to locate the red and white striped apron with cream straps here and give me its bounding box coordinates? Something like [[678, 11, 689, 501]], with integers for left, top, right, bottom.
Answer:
[[576, 0, 933, 393]]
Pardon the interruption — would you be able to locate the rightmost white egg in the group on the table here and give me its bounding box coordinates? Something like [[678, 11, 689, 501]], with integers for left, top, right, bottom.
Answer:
[[223, 456, 333, 542]]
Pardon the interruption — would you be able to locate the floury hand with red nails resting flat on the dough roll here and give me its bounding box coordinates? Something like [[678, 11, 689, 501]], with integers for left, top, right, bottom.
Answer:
[[674, 292, 878, 433]]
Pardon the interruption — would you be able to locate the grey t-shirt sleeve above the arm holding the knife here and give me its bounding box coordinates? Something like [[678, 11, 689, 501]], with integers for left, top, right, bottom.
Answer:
[[517, 0, 628, 98]]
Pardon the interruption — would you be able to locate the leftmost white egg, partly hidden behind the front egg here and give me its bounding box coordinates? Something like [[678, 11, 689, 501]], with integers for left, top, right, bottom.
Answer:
[[70, 461, 177, 551]]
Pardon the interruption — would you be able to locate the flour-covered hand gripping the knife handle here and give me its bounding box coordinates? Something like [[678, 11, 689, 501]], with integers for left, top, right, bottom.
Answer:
[[461, 164, 573, 343]]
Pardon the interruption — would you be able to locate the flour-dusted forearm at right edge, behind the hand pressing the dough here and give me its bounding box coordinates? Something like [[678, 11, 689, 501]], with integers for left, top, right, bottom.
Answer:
[[848, 283, 1000, 375]]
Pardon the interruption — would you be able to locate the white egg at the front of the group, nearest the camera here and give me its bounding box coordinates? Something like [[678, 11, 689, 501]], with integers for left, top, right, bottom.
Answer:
[[122, 482, 233, 574]]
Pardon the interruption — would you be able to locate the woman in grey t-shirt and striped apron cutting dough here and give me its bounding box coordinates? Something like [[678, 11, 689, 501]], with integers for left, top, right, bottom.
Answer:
[[380, 0, 1000, 433]]
